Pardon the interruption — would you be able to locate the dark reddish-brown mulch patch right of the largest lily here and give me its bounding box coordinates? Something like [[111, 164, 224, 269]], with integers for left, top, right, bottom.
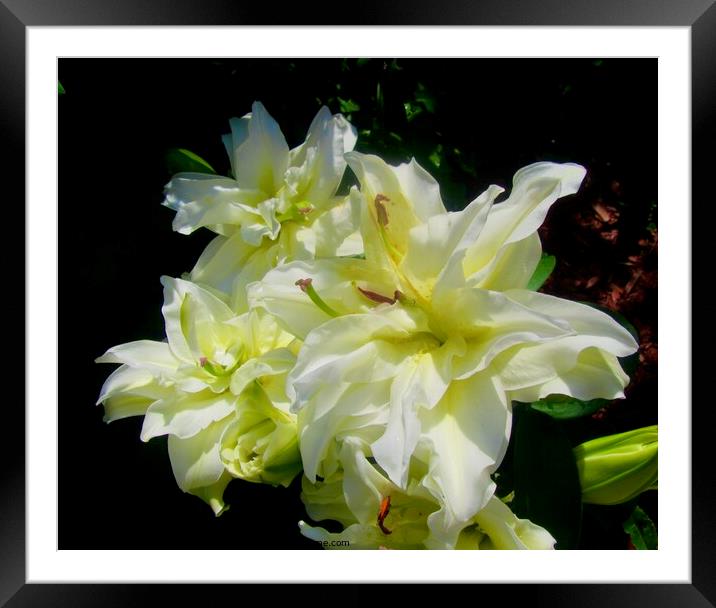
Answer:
[[540, 169, 658, 421]]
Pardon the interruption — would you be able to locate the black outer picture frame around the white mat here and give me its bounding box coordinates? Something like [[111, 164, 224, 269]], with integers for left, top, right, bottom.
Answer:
[[5, 0, 716, 607]]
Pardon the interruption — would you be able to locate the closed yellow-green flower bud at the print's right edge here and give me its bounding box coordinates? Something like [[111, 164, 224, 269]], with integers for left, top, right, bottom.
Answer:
[[574, 425, 659, 505]]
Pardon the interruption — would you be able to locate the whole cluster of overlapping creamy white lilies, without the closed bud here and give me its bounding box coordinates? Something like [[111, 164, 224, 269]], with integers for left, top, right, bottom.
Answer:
[[98, 103, 637, 549]]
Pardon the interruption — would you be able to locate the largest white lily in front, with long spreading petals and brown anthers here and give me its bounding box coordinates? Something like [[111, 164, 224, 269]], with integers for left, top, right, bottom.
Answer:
[[249, 152, 637, 547]]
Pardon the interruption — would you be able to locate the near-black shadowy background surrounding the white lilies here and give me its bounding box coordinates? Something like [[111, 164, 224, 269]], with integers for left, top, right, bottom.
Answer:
[[58, 58, 657, 549]]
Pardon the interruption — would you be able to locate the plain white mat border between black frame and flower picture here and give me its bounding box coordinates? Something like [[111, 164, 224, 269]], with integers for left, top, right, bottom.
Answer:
[[26, 27, 691, 583]]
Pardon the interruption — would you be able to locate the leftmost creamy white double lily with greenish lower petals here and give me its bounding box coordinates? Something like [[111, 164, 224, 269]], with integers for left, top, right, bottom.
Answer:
[[97, 277, 301, 515]]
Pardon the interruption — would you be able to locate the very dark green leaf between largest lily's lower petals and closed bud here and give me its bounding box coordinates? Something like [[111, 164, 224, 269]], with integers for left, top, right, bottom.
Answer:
[[512, 407, 582, 549]]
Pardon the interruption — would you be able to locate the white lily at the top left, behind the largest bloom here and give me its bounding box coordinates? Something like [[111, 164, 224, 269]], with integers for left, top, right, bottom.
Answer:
[[164, 102, 363, 309]]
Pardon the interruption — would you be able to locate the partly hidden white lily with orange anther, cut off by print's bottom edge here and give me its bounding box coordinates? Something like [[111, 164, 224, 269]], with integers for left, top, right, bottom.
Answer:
[[299, 437, 555, 550]]
